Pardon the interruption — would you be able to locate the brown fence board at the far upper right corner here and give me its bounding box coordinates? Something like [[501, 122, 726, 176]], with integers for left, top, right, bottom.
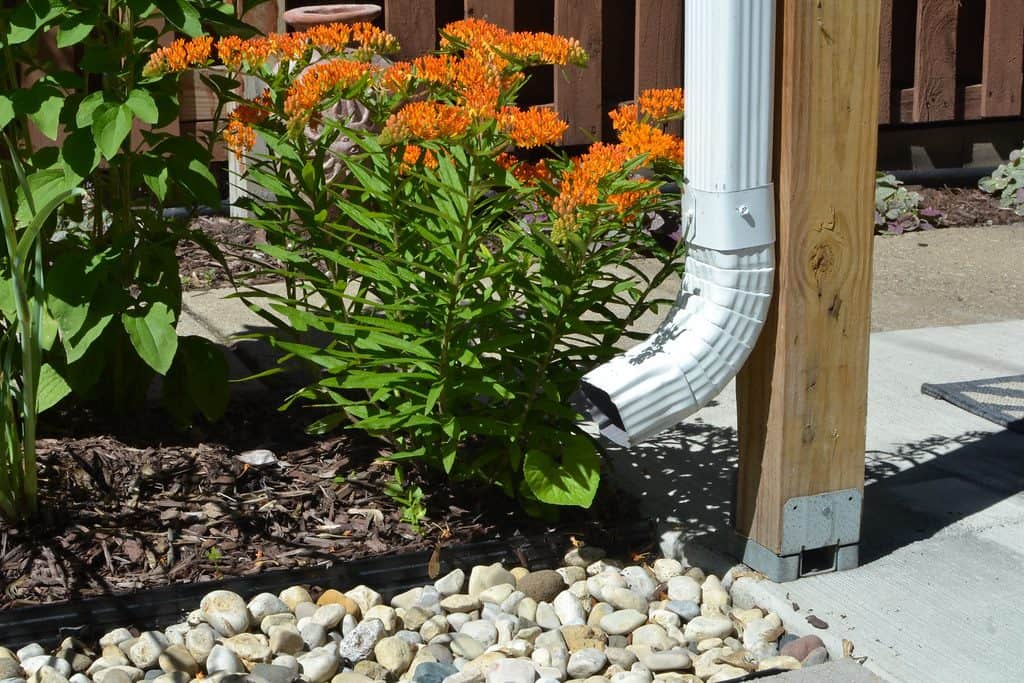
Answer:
[[981, 0, 1024, 117]]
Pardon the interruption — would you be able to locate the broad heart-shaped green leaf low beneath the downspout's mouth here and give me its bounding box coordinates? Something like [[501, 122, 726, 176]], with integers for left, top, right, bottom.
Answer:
[[522, 434, 601, 508]]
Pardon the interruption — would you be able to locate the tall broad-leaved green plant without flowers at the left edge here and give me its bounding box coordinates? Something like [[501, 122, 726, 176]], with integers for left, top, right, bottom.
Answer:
[[0, 0, 253, 420]]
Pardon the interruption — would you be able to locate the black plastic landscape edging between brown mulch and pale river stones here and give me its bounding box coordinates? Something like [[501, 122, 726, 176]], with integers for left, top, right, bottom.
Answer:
[[0, 521, 654, 649]]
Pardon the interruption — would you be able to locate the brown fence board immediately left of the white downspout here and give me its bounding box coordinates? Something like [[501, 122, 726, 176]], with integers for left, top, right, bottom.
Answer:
[[633, 0, 683, 135]]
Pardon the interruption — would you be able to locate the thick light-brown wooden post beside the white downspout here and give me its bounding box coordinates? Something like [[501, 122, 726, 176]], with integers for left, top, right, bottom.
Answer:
[[735, 0, 880, 578]]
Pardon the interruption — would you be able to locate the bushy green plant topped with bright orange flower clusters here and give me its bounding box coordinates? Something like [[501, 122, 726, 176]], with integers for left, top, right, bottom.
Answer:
[[190, 20, 682, 516]]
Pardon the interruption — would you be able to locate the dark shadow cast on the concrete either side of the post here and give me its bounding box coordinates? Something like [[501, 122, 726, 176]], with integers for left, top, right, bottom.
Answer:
[[605, 422, 1024, 564]]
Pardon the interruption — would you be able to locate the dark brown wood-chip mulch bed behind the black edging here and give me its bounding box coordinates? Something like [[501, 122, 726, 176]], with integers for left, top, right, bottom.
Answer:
[[0, 397, 632, 609]]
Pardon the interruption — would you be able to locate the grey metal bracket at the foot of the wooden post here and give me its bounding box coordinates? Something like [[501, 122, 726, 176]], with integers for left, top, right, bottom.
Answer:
[[743, 488, 863, 582]]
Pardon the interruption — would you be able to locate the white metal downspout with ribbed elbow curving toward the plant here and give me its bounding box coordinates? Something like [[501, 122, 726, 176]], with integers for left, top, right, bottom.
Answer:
[[583, 0, 775, 444]]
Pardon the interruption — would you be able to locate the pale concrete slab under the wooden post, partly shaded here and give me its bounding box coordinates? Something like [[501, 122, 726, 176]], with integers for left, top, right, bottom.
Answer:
[[609, 321, 1024, 683]]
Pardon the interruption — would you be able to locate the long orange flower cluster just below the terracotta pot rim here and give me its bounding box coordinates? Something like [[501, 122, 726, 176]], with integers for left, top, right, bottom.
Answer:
[[217, 23, 398, 71]]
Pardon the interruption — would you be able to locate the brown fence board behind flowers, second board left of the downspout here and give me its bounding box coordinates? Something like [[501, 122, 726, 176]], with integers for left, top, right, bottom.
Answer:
[[555, 0, 603, 144]]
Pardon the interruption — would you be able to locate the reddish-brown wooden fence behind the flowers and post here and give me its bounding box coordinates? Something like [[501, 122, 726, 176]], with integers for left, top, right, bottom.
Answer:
[[181, 0, 1024, 152]]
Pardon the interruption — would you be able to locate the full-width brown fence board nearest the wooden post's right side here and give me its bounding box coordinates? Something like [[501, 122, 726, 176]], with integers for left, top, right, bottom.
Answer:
[[913, 0, 958, 122]]
